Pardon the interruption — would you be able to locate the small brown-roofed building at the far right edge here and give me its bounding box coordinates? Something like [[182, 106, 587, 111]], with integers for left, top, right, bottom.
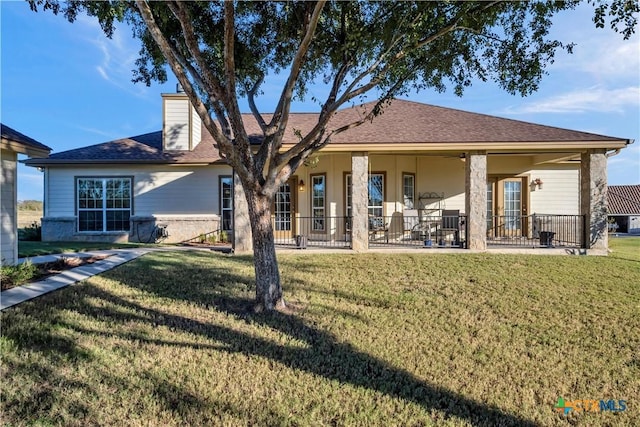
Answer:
[[607, 185, 640, 234]]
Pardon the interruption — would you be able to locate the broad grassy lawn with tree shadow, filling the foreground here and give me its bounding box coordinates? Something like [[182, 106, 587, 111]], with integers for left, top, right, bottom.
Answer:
[[0, 252, 640, 426]]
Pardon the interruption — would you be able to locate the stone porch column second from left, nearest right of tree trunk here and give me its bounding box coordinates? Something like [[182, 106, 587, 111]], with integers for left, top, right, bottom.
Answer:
[[351, 152, 369, 251]]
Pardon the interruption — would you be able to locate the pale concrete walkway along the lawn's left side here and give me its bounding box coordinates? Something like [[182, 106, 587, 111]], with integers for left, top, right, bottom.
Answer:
[[0, 248, 151, 311]]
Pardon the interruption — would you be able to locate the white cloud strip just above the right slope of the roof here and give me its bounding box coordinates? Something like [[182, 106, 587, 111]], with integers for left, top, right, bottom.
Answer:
[[502, 86, 640, 114]]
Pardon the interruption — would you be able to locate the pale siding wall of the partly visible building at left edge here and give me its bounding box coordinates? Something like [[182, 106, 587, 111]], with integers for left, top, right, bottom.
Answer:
[[0, 150, 18, 265]]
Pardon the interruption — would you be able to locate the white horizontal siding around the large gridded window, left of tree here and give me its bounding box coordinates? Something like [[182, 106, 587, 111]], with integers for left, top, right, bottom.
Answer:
[[47, 165, 231, 218]]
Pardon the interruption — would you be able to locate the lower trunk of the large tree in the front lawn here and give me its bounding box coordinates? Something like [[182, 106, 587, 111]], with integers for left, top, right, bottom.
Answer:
[[245, 190, 285, 312]]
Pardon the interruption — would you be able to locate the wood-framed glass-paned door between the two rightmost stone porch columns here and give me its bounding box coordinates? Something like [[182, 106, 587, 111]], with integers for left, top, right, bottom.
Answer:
[[487, 177, 529, 237]]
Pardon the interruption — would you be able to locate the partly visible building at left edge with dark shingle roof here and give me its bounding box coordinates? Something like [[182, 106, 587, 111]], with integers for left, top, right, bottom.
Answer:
[[0, 124, 51, 265]]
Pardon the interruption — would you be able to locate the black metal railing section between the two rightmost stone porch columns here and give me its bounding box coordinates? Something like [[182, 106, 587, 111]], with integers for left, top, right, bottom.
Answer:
[[487, 214, 584, 248]]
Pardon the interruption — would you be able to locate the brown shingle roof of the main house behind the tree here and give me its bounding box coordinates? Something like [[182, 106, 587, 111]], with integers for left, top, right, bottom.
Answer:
[[26, 99, 629, 166]]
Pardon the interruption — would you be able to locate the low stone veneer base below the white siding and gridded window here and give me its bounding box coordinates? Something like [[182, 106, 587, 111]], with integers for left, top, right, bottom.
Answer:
[[42, 215, 220, 243]]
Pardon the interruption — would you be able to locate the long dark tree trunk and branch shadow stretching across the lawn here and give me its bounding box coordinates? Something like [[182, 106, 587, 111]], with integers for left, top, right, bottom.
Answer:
[[100, 254, 535, 426]]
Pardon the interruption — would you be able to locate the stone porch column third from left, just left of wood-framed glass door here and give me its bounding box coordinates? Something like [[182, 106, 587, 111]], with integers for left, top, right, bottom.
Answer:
[[464, 151, 487, 250]]
